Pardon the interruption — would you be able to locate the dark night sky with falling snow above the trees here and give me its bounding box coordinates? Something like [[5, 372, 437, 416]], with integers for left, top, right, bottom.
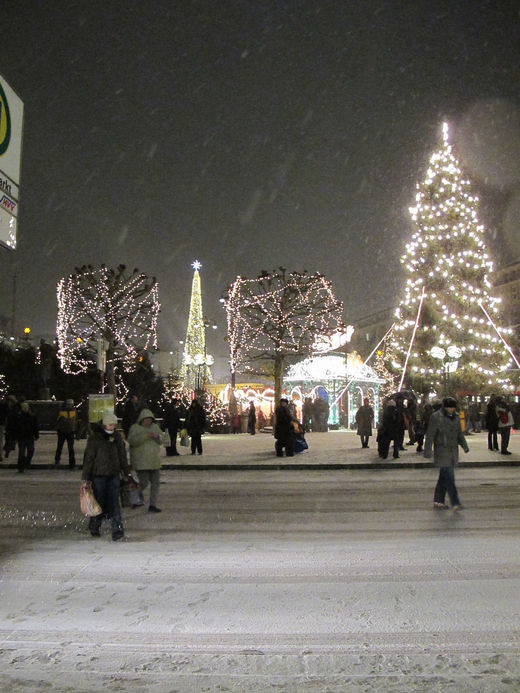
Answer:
[[0, 0, 520, 376]]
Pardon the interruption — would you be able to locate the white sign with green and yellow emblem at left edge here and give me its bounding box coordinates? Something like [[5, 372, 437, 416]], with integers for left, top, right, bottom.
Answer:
[[0, 75, 23, 250]]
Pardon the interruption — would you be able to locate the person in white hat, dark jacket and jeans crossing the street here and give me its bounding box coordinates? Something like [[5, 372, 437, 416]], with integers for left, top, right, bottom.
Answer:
[[81, 411, 130, 541]]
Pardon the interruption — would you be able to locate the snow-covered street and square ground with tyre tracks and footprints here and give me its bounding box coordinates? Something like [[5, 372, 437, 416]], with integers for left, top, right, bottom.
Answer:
[[0, 433, 520, 693]]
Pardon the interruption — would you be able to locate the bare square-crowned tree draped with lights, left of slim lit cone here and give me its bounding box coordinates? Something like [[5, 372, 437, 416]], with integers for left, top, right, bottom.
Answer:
[[57, 265, 160, 394]]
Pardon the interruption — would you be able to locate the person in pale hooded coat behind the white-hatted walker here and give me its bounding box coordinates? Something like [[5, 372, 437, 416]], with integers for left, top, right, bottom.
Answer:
[[128, 409, 162, 513]]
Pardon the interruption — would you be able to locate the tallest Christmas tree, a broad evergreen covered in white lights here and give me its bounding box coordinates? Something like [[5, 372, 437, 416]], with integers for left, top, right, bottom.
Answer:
[[385, 123, 511, 393]]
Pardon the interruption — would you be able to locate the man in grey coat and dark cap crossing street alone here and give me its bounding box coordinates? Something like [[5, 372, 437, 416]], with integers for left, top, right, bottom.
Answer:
[[424, 397, 469, 510]]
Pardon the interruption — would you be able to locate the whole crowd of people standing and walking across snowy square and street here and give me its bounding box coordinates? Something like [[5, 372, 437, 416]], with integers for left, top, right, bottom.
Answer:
[[0, 391, 515, 541]]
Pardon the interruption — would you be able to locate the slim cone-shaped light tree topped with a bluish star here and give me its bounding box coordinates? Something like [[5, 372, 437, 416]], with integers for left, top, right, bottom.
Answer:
[[180, 260, 213, 389]]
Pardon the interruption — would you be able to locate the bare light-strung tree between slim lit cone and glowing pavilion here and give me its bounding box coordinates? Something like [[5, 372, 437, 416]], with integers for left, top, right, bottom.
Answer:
[[222, 267, 345, 401]]
